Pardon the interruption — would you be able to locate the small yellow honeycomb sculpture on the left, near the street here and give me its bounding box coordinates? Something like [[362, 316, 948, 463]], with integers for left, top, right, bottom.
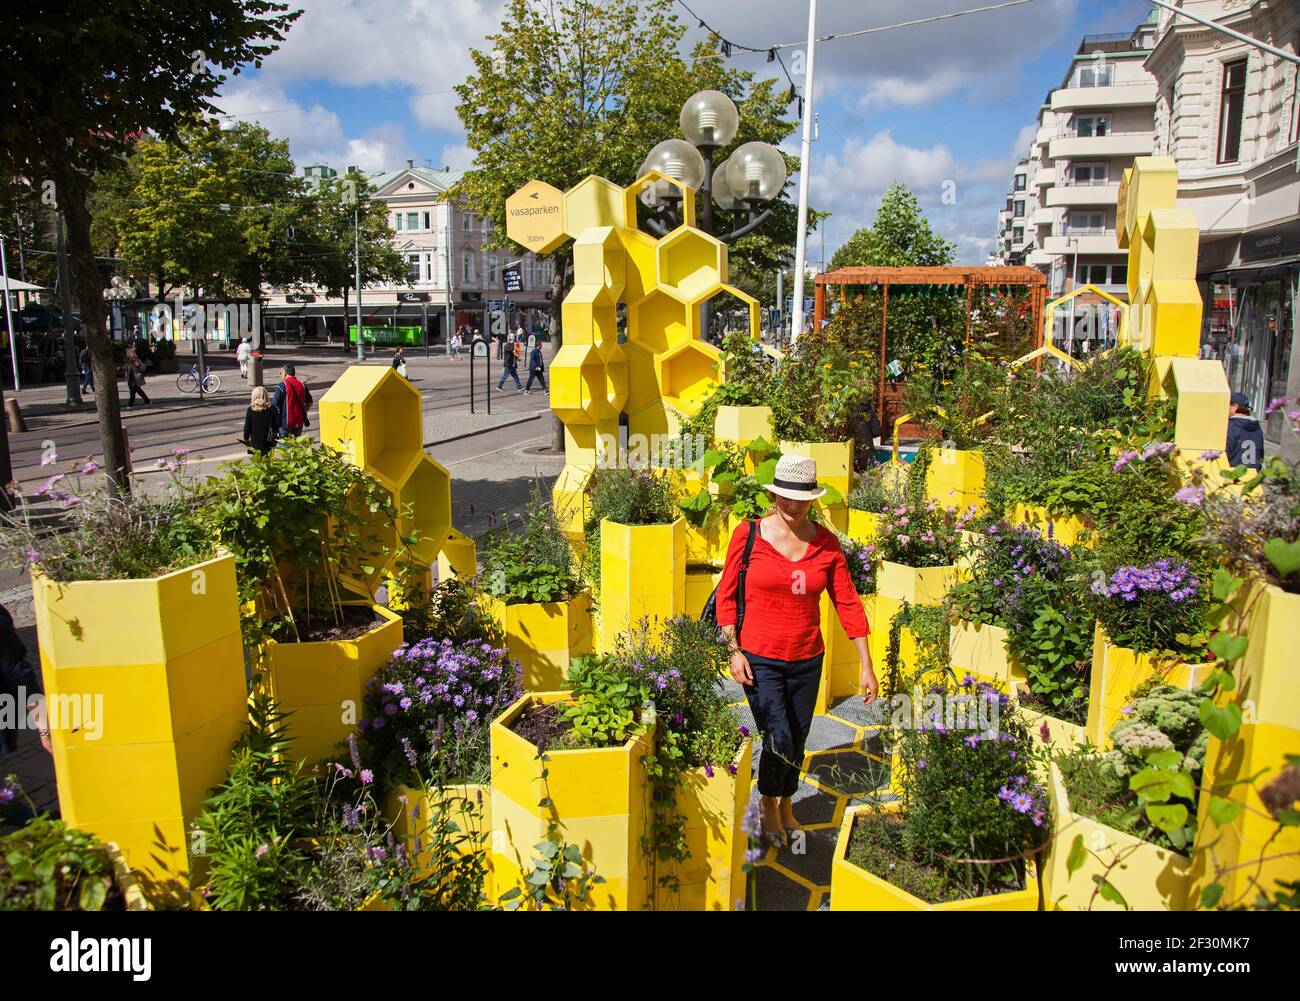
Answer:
[[320, 365, 451, 573]]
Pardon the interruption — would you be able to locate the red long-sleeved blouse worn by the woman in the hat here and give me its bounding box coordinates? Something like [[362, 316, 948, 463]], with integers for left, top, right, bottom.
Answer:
[[718, 521, 870, 660]]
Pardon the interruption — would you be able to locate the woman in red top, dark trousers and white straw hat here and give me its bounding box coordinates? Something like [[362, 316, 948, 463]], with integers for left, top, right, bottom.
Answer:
[[718, 455, 878, 848]]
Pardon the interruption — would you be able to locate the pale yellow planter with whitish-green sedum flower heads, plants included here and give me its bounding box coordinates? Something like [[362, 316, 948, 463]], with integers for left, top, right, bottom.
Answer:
[[1047, 684, 1209, 910]]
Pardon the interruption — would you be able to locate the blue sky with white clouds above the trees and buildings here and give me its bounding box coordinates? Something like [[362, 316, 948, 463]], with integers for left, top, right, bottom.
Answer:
[[221, 0, 1151, 263]]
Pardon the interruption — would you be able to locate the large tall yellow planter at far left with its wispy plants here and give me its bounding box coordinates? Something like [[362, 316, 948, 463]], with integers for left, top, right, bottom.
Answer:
[[0, 451, 247, 902]]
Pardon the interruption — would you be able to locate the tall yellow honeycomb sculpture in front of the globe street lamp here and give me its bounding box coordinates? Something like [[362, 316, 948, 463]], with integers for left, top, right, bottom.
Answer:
[[506, 173, 759, 540]]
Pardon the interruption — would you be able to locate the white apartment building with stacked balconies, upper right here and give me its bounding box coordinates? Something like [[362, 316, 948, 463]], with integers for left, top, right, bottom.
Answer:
[[997, 14, 1157, 350]]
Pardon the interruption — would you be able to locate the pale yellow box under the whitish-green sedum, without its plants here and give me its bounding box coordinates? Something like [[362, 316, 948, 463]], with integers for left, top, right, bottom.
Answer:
[[1044, 762, 1191, 910]]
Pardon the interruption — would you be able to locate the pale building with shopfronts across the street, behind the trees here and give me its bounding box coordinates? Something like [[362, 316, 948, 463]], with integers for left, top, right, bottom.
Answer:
[[263, 160, 554, 345]]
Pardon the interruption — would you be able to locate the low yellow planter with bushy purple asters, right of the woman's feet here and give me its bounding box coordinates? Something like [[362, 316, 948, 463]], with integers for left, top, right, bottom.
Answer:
[[831, 679, 1052, 910]]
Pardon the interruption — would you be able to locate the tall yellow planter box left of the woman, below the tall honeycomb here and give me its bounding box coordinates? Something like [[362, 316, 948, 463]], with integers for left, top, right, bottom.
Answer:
[[599, 517, 686, 651]]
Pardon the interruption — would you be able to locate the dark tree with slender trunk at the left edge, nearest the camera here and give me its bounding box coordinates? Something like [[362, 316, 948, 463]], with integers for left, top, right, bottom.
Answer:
[[0, 0, 302, 491]]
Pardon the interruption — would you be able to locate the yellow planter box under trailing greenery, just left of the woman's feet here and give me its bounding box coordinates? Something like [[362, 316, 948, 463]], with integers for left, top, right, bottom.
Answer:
[[655, 737, 754, 910]]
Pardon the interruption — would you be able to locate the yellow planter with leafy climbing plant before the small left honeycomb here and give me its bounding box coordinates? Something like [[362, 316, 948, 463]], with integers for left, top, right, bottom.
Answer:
[[204, 438, 402, 761]]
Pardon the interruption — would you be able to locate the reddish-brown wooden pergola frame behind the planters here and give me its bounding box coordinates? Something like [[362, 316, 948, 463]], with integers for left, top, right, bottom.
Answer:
[[813, 267, 1048, 424]]
